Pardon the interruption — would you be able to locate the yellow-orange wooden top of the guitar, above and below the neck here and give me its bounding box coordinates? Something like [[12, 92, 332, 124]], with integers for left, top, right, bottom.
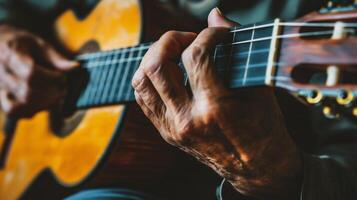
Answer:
[[0, 0, 141, 200]]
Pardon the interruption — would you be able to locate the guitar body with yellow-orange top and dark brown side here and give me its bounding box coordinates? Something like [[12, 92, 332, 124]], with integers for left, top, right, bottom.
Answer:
[[0, 0, 202, 200]]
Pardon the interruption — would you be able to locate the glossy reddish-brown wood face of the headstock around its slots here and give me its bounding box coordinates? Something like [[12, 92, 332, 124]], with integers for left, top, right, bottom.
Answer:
[[276, 12, 357, 92]]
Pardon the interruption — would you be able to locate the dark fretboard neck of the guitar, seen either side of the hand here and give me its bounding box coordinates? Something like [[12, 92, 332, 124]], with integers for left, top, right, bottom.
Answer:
[[70, 20, 279, 109]]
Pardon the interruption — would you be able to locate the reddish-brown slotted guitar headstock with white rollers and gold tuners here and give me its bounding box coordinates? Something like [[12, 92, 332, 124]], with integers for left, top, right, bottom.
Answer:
[[275, 4, 357, 119]]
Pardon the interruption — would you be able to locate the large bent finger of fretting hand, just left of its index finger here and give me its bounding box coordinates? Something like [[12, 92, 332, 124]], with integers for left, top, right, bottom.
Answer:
[[140, 31, 196, 112]]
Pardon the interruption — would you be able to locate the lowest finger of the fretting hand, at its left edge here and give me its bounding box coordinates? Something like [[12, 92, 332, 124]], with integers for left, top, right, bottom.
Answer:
[[133, 69, 166, 119]]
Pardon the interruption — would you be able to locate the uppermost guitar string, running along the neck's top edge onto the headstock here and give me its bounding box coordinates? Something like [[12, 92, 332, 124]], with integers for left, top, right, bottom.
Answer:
[[77, 22, 357, 59]]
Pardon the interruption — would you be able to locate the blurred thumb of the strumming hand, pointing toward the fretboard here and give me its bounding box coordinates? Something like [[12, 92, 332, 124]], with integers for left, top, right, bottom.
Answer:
[[46, 47, 79, 71]]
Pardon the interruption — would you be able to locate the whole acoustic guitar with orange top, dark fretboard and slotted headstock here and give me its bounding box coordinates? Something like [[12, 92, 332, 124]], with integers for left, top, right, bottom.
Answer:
[[0, 0, 357, 199]]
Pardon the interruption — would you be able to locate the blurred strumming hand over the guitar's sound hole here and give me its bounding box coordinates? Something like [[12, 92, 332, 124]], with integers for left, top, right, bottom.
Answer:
[[0, 25, 76, 117]]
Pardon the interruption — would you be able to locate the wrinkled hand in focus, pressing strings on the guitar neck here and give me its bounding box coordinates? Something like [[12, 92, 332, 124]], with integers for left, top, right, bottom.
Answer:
[[132, 9, 301, 199]]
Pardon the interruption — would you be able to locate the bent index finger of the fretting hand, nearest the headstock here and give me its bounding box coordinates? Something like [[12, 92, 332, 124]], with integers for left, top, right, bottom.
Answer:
[[182, 27, 228, 95]]
